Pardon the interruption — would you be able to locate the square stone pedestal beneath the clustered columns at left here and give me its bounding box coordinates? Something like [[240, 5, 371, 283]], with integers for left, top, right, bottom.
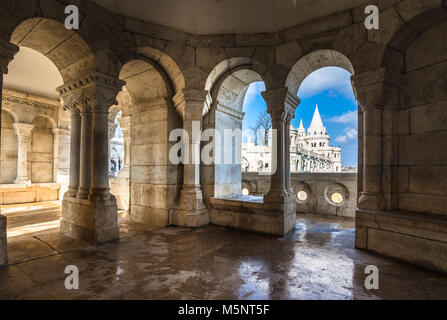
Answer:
[[60, 196, 119, 244]]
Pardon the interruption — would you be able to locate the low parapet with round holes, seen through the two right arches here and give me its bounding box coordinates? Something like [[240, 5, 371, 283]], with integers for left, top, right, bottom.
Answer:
[[242, 173, 357, 218]]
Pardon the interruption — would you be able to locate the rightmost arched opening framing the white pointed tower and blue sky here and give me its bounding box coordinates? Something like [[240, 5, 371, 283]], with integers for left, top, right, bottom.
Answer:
[[287, 50, 362, 220]]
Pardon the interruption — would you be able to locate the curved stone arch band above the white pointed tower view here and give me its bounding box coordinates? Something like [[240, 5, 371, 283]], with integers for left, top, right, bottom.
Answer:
[[286, 49, 354, 96]]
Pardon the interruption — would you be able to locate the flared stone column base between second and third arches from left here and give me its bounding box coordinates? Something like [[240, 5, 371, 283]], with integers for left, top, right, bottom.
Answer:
[[171, 186, 210, 227]]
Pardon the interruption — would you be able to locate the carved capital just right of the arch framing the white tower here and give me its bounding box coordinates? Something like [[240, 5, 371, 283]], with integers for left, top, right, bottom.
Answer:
[[351, 68, 403, 111]]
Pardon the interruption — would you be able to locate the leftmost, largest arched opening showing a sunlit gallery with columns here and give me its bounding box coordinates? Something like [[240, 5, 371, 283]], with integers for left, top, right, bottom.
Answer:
[[0, 18, 94, 263]]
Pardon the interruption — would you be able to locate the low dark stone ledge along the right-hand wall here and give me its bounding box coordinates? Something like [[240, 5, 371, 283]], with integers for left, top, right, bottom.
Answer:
[[355, 210, 447, 272]]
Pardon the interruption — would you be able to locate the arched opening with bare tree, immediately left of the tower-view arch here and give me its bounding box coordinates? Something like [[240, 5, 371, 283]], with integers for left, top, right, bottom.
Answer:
[[200, 61, 270, 206]]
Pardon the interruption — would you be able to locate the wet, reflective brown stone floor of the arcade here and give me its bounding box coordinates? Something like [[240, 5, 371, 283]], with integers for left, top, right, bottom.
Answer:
[[0, 209, 447, 300]]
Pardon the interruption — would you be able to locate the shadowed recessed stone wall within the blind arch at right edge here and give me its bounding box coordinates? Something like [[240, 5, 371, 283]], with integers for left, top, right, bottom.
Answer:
[[397, 22, 447, 215]]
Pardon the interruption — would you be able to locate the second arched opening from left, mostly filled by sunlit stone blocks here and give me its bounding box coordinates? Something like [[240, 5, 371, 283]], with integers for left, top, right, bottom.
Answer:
[[116, 54, 184, 229]]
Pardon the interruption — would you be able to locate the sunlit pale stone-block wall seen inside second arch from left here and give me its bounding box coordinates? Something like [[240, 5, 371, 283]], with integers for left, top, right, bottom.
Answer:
[[130, 99, 181, 228]]
